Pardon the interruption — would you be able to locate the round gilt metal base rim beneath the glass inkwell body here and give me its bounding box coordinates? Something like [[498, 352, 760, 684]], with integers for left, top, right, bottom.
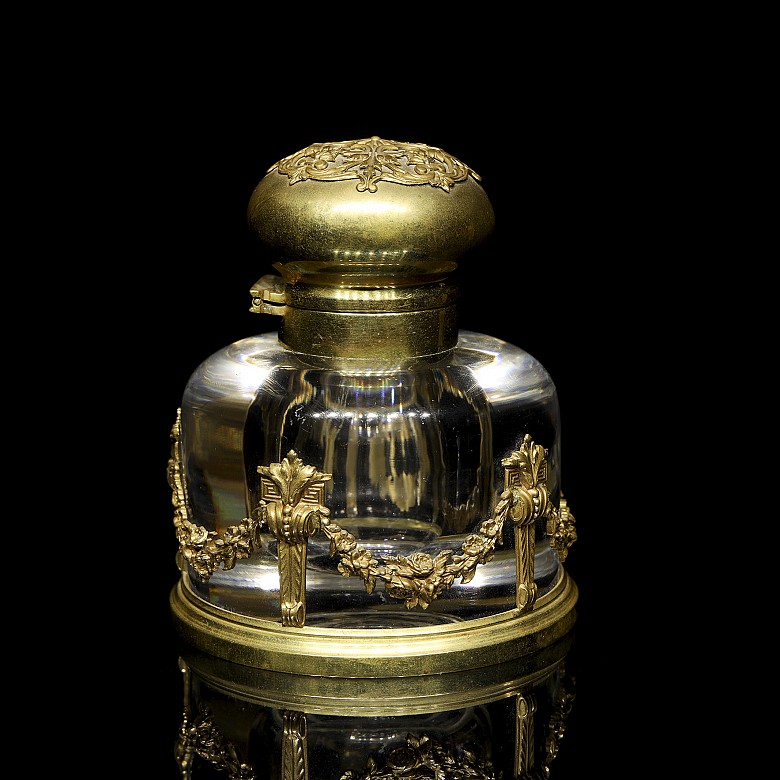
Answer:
[[170, 569, 578, 678]]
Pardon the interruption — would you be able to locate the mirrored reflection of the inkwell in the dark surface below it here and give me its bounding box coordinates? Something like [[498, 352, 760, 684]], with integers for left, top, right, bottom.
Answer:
[[176, 635, 575, 780]]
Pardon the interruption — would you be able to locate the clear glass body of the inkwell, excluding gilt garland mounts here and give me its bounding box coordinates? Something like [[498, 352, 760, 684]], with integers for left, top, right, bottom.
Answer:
[[181, 331, 560, 628]]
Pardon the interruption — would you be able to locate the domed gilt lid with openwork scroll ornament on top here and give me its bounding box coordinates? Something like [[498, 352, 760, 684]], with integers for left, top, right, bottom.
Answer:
[[248, 136, 495, 287]]
